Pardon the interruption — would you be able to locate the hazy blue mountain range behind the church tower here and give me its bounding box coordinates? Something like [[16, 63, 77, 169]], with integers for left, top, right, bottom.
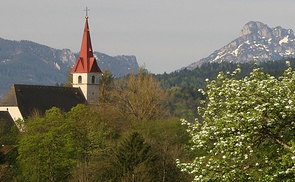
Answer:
[[0, 38, 139, 99]]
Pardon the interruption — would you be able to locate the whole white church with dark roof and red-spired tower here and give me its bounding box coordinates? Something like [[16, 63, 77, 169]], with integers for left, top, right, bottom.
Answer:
[[0, 15, 102, 124]]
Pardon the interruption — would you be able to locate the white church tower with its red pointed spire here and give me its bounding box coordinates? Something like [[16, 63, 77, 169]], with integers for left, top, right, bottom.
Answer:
[[71, 14, 102, 103]]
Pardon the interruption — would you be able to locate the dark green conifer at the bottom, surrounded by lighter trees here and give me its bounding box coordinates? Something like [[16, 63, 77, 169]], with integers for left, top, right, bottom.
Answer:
[[111, 132, 157, 182]]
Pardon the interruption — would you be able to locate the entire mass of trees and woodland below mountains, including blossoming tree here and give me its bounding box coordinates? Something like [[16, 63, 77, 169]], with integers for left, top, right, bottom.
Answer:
[[0, 59, 295, 182]]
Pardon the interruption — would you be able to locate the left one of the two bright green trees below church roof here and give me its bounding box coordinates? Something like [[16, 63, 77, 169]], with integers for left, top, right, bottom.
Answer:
[[18, 108, 76, 182]]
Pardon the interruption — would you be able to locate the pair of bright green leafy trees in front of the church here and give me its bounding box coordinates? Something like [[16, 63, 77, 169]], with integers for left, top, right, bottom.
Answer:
[[18, 105, 110, 181]]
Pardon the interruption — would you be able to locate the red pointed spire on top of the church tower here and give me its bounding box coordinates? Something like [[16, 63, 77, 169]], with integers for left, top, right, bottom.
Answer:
[[71, 16, 102, 73]]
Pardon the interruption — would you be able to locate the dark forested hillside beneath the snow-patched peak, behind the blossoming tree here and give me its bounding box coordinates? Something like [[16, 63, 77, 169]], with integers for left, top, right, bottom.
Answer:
[[155, 59, 295, 121]]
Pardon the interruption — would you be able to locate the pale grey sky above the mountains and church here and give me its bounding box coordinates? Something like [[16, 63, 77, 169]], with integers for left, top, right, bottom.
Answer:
[[0, 0, 295, 73]]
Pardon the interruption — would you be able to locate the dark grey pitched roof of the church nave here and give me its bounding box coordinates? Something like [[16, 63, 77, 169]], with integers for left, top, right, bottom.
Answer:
[[0, 84, 86, 118]]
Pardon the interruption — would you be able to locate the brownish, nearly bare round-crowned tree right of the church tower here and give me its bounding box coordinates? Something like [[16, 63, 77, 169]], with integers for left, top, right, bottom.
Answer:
[[109, 69, 166, 120]]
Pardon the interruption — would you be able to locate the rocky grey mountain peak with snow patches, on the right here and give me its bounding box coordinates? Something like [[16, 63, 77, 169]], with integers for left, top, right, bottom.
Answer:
[[186, 21, 295, 69]]
